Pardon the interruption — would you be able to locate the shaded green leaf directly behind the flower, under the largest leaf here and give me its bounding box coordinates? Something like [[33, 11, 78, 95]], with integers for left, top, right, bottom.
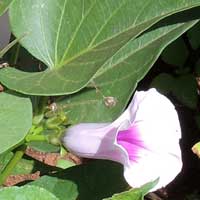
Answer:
[[58, 9, 199, 123]]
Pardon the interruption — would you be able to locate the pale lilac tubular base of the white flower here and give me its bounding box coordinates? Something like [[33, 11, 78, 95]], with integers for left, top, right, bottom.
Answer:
[[62, 123, 128, 164]]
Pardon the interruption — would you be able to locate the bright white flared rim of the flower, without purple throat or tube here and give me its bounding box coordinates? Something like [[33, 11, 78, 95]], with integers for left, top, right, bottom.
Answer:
[[121, 89, 182, 190]]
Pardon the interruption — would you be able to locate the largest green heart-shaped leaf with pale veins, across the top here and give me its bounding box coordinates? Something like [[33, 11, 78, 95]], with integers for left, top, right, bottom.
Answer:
[[0, 0, 200, 95]]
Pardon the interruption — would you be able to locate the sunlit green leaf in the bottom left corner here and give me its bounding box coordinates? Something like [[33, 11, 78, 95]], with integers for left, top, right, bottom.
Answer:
[[0, 185, 59, 200]]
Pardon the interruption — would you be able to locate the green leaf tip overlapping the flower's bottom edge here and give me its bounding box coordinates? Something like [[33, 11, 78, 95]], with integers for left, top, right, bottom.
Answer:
[[103, 180, 158, 200]]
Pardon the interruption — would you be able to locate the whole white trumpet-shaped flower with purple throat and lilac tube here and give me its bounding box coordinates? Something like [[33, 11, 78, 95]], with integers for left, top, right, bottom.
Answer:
[[63, 89, 182, 190]]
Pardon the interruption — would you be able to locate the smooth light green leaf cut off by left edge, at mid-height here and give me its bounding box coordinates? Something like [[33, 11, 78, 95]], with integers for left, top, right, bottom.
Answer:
[[0, 92, 32, 154]]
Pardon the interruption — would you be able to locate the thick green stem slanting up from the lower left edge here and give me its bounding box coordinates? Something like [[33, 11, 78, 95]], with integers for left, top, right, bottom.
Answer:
[[0, 145, 26, 185]]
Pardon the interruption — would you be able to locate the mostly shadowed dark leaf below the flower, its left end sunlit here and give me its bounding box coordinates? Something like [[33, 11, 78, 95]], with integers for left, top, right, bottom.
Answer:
[[29, 160, 128, 200]]
